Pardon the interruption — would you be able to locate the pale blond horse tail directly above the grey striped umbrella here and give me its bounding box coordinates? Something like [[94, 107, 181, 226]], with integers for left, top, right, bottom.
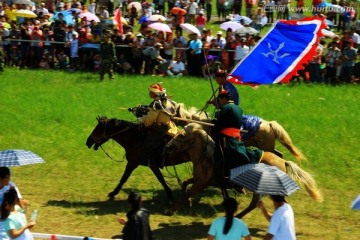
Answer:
[[285, 161, 324, 202]]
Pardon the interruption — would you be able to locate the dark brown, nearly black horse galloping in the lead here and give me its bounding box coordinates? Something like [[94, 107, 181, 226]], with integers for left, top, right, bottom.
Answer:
[[86, 117, 190, 201]]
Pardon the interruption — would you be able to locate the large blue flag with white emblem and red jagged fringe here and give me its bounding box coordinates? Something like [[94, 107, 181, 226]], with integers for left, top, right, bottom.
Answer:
[[229, 18, 326, 84]]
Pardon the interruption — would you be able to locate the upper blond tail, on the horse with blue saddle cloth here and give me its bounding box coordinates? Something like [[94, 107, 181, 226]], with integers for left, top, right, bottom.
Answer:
[[269, 121, 306, 163]]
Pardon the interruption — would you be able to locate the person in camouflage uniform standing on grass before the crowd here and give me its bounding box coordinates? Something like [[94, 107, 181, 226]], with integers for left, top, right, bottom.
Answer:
[[100, 34, 116, 80]]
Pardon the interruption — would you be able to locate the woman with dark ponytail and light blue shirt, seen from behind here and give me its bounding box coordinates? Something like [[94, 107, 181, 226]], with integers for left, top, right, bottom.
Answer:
[[208, 198, 251, 240]]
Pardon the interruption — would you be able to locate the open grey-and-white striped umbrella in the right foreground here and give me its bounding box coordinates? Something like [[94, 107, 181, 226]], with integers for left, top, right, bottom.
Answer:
[[230, 163, 299, 196]]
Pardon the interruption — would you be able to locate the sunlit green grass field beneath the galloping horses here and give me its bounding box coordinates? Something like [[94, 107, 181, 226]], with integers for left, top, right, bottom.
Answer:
[[0, 68, 360, 240]]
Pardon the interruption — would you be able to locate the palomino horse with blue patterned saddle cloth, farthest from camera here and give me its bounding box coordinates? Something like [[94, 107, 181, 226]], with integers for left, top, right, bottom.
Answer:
[[176, 103, 306, 162]]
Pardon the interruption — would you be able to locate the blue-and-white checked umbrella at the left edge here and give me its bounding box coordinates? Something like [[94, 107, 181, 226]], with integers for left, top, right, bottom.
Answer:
[[0, 150, 44, 167]]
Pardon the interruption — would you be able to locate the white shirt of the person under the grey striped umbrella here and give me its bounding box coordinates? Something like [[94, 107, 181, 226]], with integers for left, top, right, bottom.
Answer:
[[267, 203, 296, 240]]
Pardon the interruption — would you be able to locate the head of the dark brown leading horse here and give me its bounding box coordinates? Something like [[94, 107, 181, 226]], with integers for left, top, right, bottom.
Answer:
[[86, 116, 121, 150]]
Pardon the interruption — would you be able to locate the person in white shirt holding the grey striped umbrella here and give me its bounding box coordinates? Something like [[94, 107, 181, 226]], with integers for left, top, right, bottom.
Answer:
[[258, 195, 296, 240]]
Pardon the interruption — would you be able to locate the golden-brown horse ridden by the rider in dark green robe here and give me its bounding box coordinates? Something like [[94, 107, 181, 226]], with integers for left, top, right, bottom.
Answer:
[[166, 126, 322, 218]]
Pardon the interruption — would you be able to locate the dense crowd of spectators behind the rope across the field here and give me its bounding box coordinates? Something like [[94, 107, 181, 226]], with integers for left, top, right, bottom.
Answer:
[[0, 0, 360, 84]]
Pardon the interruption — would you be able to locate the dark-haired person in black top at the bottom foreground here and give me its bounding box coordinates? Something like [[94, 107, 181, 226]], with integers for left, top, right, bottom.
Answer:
[[118, 192, 153, 240]]
